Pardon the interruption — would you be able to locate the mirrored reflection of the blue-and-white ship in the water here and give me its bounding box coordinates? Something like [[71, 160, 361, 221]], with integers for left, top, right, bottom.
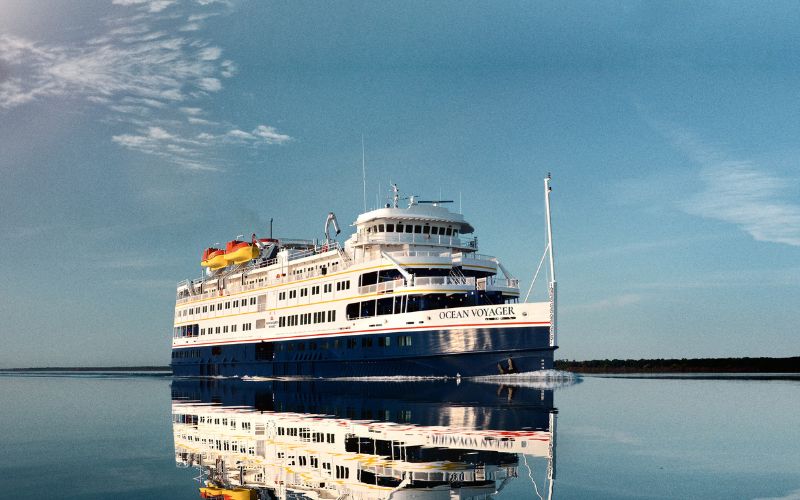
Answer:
[[172, 379, 557, 500]]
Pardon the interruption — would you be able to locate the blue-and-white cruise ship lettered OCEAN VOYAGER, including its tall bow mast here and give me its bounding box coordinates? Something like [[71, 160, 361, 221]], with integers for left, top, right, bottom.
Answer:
[[171, 175, 557, 377]]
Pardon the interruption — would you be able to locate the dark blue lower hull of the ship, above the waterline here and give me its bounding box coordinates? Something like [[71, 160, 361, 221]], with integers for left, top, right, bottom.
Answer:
[[172, 326, 555, 378]]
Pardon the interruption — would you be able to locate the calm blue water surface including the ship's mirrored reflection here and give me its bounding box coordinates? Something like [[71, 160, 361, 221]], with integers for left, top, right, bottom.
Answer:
[[0, 374, 800, 499]]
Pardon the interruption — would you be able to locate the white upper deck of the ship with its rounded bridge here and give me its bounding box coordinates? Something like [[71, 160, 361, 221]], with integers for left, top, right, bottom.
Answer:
[[177, 188, 490, 304]]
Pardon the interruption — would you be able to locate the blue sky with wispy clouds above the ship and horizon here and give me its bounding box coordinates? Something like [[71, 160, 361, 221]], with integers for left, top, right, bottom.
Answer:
[[0, 0, 800, 367]]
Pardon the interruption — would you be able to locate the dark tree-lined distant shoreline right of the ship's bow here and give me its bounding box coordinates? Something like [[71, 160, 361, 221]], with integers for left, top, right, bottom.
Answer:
[[555, 356, 800, 374]]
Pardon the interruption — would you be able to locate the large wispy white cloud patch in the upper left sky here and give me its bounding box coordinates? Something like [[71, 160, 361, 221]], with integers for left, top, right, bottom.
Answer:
[[0, 0, 292, 171]]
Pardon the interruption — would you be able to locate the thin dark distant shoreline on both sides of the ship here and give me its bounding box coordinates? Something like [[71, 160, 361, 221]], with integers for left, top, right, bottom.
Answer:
[[0, 356, 800, 374]]
